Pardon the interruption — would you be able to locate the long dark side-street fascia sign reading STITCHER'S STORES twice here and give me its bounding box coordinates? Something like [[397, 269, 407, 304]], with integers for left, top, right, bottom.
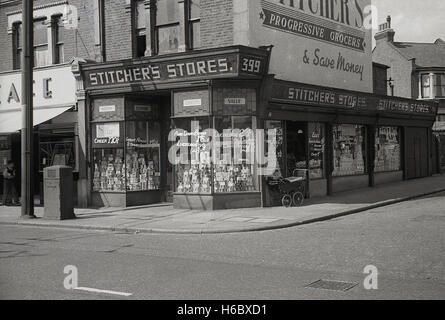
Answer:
[[272, 82, 437, 116]]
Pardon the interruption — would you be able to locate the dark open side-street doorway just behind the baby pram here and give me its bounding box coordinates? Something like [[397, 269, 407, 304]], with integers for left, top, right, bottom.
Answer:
[[286, 121, 308, 177]]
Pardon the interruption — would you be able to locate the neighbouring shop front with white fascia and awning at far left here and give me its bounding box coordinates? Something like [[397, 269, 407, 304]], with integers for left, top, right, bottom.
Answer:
[[0, 64, 79, 204]]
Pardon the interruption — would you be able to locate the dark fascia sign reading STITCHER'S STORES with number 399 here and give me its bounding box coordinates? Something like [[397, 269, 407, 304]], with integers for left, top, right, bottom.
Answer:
[[84, 53, 267, 89]]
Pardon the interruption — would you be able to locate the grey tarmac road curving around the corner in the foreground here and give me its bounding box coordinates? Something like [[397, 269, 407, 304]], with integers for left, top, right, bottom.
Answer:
[[0, 194, 445, 300]]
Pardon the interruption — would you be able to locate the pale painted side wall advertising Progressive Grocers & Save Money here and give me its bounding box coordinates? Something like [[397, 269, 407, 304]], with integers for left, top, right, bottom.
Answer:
[[249, 0, 372, 93]]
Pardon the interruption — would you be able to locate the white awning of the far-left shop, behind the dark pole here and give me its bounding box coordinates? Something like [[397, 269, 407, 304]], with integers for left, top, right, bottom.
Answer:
[[0, 106, 73, 134]]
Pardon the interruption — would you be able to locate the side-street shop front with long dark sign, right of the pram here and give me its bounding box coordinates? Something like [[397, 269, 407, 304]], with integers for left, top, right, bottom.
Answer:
[[265, 80, 437, 204]]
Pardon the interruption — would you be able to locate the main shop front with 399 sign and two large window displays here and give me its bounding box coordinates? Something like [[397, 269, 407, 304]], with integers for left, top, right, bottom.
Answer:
[[81, 46, 270, 210]]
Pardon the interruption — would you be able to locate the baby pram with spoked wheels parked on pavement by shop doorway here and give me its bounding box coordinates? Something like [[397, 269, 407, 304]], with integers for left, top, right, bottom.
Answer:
[[267, 169, 308, 208]]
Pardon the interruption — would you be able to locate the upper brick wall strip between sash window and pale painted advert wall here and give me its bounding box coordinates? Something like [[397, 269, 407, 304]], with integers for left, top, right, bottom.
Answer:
[[201, 0, 234, 48]]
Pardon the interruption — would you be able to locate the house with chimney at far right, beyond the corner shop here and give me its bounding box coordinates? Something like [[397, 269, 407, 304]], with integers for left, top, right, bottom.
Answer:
[[373, 16, 445, 173]]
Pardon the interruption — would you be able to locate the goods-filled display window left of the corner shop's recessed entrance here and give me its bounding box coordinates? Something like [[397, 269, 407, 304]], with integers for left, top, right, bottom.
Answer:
[[93, 120, 161, 192]]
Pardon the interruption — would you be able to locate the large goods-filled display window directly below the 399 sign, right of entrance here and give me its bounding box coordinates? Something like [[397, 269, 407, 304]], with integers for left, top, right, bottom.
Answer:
[[173, 116, 259, 194]]
